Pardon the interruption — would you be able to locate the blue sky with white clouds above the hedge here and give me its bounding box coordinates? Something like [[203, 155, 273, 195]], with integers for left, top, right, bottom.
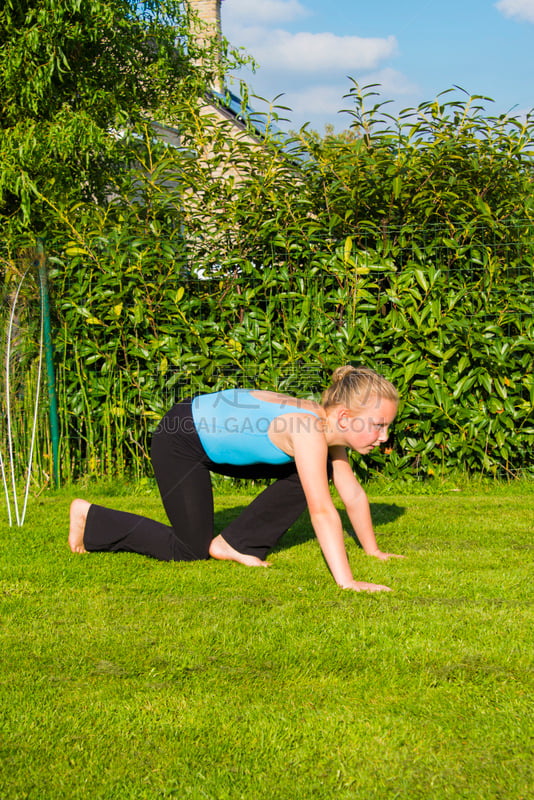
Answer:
[[221, 0, 534, 133]]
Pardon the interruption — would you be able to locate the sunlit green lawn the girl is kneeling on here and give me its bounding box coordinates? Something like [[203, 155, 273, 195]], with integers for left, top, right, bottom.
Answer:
[[0, 483, 534, 800]]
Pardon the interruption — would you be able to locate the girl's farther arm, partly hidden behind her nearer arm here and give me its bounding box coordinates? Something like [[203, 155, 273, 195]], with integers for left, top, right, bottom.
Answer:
[[330, 447, 402, 560]]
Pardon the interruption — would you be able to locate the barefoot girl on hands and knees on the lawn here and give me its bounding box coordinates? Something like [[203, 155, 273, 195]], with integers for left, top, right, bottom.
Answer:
[[69, 366, 406, 592]]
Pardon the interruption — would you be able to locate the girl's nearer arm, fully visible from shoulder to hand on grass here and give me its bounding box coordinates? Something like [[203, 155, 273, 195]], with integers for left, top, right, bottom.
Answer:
[[293, 431, 389, 592]]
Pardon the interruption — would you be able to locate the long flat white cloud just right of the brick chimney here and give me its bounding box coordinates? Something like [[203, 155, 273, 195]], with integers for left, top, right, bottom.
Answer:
[[224, 27, 397, 74]]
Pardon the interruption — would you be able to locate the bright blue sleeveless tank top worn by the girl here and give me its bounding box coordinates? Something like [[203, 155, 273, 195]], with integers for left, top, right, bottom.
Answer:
[[191, 389, 319, 466]]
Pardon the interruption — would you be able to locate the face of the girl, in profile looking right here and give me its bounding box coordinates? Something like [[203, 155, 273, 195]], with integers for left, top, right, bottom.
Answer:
[[337, 397, 397, 455]]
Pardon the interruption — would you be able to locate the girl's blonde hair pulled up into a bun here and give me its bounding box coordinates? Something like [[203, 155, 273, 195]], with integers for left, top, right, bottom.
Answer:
[[322, 365, 399, 408]]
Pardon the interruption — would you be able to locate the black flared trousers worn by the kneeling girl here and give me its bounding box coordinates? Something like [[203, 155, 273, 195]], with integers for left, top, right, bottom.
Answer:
[[84, 400, 306, 561]]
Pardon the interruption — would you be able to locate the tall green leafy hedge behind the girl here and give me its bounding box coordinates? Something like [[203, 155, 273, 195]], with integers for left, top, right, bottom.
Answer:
[[1, 87, 534, 479]]
